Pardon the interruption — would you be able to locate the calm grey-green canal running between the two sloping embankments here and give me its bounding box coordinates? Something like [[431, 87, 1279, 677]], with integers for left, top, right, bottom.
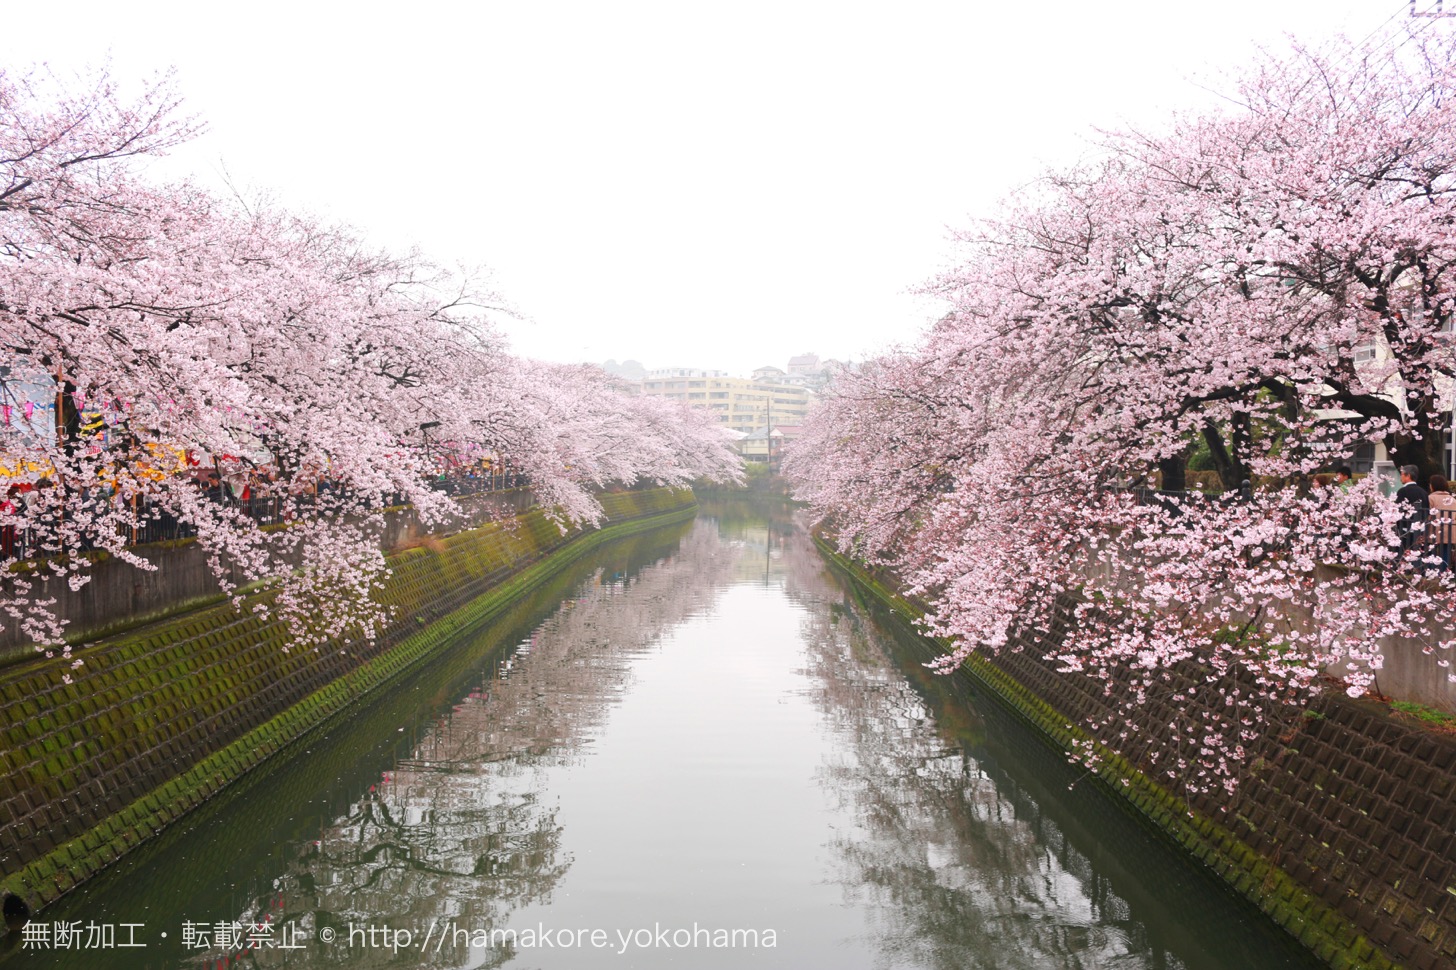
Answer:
[[0, 500, 1313, 970]]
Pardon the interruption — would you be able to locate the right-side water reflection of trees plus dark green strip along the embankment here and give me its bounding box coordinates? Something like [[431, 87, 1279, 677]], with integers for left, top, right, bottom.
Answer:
[[796, 544, 1316, 970]]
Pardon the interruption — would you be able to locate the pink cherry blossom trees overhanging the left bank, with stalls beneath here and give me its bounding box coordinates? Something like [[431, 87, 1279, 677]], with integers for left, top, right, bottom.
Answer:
[[0, 66, 735, 658]]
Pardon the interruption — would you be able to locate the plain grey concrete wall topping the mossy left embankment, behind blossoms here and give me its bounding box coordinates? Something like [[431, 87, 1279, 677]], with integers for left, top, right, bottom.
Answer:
[[0, 489, 531, 664]]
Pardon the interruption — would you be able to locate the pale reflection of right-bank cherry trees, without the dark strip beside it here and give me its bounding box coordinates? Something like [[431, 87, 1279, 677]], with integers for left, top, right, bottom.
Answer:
[[804, 588, 1147, 967]]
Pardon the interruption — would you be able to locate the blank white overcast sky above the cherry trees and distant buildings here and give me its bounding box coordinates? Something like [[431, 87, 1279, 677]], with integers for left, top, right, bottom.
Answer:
[[0, 0, 1432, 374]]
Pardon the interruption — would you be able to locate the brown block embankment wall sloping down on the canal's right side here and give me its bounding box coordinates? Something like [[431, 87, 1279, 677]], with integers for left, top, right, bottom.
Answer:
[[823, 535, 1456, 970]]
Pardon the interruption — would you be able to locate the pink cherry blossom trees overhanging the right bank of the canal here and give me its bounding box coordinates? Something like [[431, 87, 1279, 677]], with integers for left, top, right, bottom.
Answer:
[[786, 28, 1456, 789]]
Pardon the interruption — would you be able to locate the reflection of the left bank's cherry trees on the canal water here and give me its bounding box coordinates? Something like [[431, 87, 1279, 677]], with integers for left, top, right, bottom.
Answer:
[[198, 523, 743, 967]]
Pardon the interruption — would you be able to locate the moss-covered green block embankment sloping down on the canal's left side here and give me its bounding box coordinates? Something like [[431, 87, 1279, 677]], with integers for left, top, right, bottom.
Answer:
[[0, 489, 696, 912]]
